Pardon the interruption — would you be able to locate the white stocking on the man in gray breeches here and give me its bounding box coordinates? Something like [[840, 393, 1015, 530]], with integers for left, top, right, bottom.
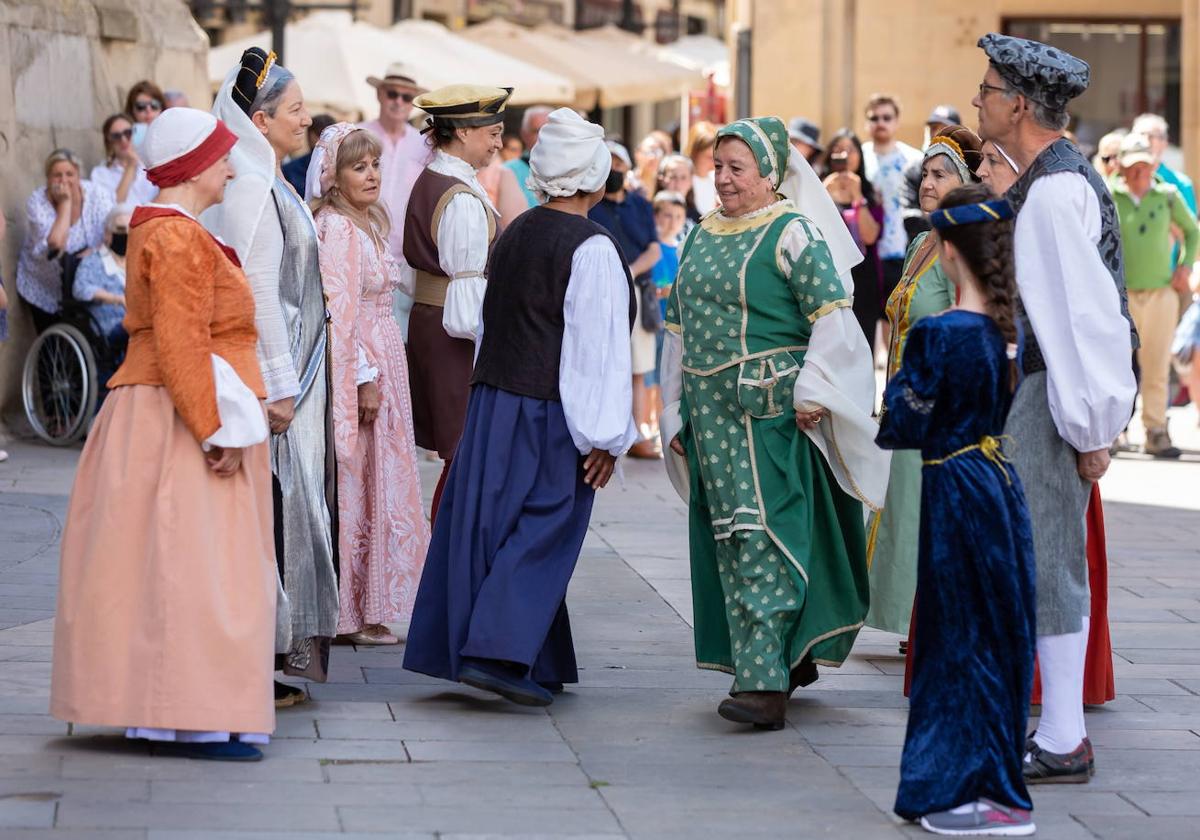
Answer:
[[1033, 616, 1088, 755]]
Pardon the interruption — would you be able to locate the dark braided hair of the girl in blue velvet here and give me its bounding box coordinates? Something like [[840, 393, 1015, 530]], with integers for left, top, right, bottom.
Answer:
[[937, 184, 1016, 344]]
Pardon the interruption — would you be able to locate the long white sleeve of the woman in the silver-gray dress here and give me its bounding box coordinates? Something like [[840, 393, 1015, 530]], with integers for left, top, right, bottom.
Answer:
[[242, 205, 300, 402]]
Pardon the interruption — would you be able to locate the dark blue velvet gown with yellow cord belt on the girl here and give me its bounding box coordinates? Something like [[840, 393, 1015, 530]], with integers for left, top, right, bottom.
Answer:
[[877, 310, 1036, 820]]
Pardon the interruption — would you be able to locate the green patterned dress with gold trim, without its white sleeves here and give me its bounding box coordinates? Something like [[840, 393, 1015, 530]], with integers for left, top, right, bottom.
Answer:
[[667, 200, 868, 692]]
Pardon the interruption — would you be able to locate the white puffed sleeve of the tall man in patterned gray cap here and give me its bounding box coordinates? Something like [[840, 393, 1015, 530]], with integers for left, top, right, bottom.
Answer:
[[1014, 172, 1138, 452]]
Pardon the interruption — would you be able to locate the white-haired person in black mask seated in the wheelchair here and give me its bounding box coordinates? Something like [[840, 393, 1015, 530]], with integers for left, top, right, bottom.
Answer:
[[71, 206, 130, 378]]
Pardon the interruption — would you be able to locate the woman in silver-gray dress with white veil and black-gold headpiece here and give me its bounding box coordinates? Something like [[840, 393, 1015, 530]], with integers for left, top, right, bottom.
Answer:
[[204, 48, 338, 706]]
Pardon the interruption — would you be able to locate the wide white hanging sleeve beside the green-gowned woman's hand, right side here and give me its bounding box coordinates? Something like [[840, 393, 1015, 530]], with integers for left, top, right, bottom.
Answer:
[[793, 306, 892, 510]]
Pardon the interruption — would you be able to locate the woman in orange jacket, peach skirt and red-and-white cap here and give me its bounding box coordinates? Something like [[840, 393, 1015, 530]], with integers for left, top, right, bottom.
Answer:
[[50, 108, 276, 761]]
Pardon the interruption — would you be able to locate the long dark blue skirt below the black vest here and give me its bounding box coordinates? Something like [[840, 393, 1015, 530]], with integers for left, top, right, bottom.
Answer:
[[404, 385, 594, 683]]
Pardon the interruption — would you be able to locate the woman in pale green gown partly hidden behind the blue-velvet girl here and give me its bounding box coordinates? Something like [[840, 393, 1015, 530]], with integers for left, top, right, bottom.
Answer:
[[866, 126, 983, 638]]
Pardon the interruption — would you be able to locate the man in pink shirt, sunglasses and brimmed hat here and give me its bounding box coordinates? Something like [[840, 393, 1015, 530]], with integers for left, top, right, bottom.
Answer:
[[359, 64, 433, 340]]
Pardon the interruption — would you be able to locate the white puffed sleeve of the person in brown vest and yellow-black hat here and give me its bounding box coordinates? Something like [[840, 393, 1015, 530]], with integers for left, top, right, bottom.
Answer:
[[438, 193, 488, 341]]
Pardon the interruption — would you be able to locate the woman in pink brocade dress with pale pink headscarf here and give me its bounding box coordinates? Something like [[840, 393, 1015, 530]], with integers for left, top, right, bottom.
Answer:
[[307, 122, 430, 644]]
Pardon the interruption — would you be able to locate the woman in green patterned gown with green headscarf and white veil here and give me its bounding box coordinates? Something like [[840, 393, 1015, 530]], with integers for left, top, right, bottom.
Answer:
[[662, 118, 888, 728]]
